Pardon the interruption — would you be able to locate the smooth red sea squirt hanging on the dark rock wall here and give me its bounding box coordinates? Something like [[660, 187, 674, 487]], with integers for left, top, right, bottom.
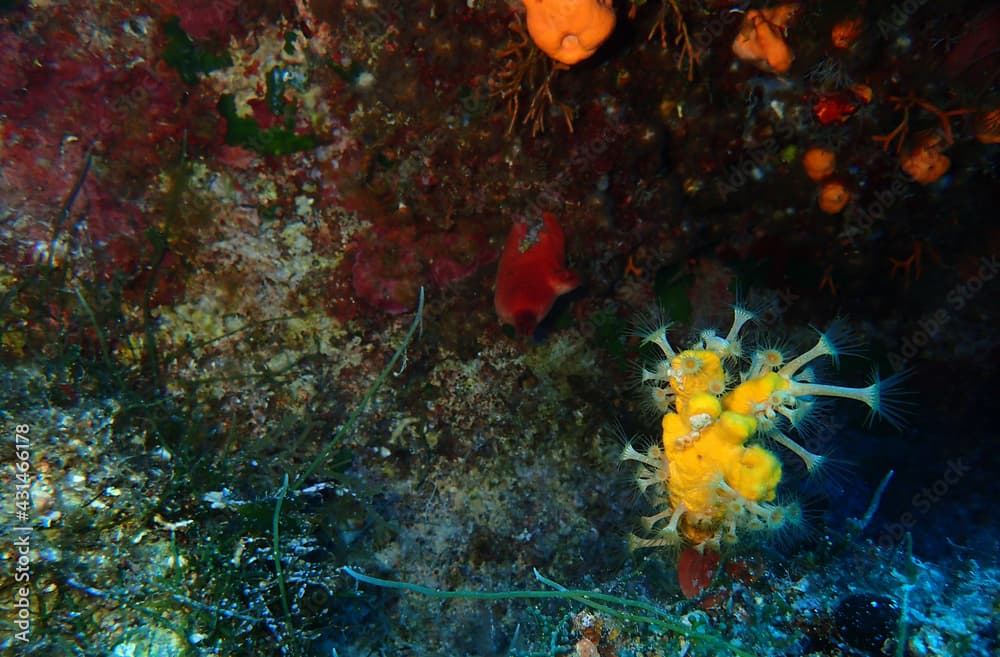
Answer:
[[493, 212, 580, 335]]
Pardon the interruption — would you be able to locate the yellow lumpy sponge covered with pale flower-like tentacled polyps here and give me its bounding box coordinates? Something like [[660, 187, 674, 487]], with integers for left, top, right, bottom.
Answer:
[[622, 307, 900, 550]]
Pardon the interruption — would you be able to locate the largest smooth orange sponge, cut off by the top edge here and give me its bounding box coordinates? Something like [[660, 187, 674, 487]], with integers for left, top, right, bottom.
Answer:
[[524, 0, 615, 64]]
